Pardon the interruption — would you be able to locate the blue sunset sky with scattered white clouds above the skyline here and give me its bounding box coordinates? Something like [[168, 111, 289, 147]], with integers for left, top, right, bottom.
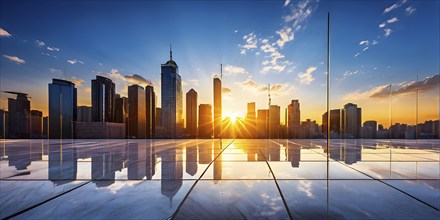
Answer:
[[0, 0, 440, 125]]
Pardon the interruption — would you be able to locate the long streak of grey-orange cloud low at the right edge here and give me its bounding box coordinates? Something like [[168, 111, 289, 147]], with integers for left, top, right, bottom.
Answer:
[[344, 74, 440, 100]]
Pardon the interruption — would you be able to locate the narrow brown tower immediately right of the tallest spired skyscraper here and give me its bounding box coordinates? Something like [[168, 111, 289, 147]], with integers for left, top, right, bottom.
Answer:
[[186, 89, 197, 138]]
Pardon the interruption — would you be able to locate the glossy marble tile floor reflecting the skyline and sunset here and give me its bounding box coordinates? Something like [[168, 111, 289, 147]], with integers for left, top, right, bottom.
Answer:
[[0, 139, 440, 219]]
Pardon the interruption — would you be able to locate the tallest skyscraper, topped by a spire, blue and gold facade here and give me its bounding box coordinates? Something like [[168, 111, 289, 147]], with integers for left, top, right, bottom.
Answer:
[[160, 48, 183, 138]]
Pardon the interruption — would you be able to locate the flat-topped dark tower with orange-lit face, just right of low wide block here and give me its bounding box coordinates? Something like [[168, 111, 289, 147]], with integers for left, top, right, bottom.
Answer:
[[128, 85, 147, 138]]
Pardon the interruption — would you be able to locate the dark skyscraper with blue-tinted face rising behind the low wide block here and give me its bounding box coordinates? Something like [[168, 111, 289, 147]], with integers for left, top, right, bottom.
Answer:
[[92, 76, 115, 122]]
